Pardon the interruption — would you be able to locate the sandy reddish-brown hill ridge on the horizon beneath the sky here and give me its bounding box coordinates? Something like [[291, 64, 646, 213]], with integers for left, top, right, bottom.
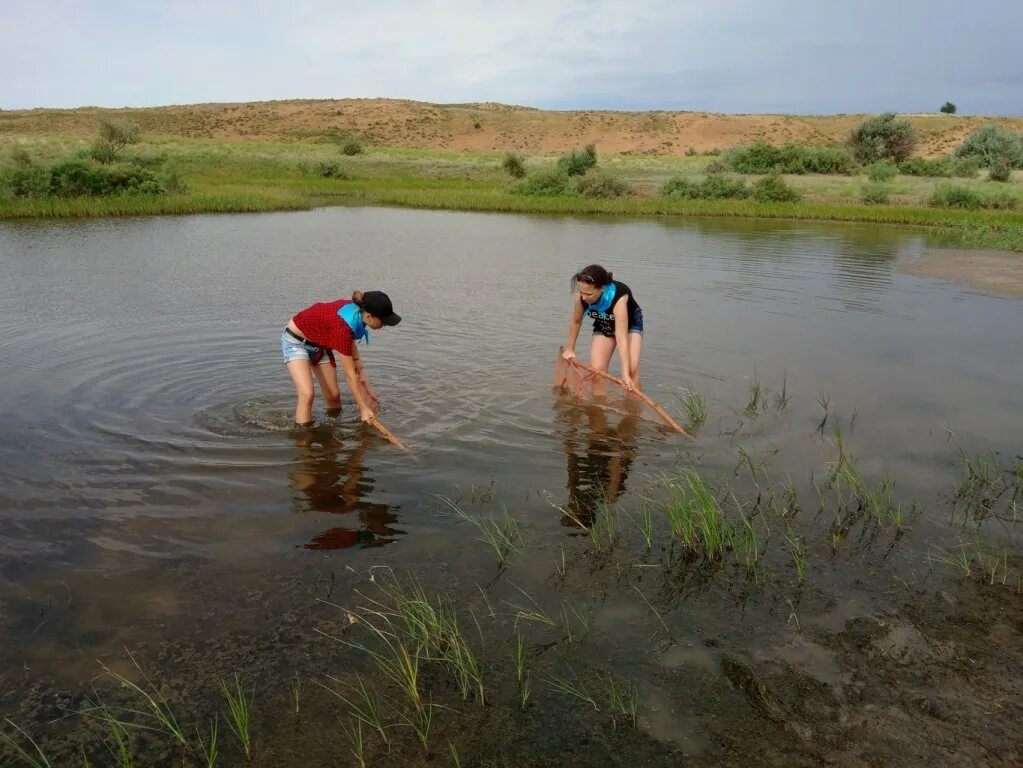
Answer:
[[0, 99, 1023, 155]]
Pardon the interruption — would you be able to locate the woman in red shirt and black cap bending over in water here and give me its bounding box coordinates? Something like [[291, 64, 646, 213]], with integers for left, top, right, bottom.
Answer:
[[280, 290, 401, 426]]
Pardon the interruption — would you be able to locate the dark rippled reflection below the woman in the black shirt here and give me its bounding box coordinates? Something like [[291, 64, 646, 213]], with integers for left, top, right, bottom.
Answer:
[[554, 395, 641, 528]]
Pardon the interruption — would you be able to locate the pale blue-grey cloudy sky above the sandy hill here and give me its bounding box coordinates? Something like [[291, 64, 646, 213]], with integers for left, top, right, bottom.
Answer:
[[0, 0, 1023, 115]]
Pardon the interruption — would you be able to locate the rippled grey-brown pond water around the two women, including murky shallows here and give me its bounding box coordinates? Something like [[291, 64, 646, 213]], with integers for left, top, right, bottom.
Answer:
[[0, 208, 1023, 765]]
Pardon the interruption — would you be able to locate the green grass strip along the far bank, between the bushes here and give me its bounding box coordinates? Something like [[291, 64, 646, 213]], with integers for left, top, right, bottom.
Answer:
[[6, 136, 1023, 251]]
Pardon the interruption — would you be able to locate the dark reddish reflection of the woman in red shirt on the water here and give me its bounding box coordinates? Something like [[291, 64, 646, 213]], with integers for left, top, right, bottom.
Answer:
[[292, 426, 405, 549]]
